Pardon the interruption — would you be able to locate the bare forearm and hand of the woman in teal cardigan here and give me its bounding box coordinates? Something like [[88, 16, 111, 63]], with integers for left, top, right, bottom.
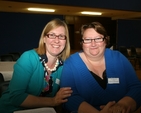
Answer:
[[21, 87, 72, 108]]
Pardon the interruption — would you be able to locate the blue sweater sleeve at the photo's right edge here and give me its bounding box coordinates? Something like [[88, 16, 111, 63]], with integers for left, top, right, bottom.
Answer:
[[115, 51, 141, 109]]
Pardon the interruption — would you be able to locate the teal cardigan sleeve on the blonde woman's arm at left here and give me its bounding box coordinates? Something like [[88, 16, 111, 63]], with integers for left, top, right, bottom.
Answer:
[[2, 50, 42, 106]]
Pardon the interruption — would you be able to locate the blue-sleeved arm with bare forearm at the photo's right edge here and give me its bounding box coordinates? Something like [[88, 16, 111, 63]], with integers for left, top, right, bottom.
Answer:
[[109, 54, 141, 112]]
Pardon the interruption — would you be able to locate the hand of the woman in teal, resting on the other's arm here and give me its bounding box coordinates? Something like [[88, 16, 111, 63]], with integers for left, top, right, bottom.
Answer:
[[53, 87, 73, 106]]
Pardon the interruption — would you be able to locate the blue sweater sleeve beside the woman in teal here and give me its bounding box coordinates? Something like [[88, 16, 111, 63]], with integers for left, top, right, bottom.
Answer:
[[61, 54, 84, 111]]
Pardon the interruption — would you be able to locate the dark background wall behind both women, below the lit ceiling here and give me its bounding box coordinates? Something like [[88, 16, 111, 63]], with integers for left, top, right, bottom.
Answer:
[[0, 12, 141, 55]]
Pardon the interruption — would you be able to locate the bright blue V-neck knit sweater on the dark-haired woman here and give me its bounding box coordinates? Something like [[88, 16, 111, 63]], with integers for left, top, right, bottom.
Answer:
[[61, 49, 141, 111]]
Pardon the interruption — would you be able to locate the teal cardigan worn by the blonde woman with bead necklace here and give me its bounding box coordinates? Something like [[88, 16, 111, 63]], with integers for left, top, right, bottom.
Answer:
[[0, 50, 63, 113]]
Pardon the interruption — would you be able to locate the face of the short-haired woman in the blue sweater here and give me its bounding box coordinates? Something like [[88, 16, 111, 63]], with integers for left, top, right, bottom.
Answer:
[[82, 28, 106, 57]]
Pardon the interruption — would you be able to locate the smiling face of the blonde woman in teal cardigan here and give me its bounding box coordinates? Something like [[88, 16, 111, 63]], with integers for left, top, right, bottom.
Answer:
[[44, 26, 66, 56]]
